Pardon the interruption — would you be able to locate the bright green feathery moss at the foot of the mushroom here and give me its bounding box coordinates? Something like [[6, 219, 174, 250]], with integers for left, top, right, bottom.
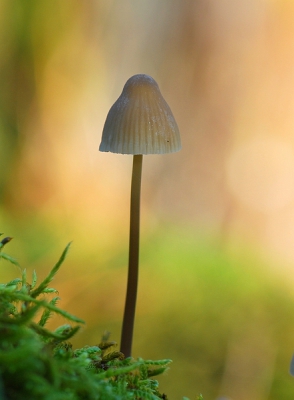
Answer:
[[0, 238, 185, 400]]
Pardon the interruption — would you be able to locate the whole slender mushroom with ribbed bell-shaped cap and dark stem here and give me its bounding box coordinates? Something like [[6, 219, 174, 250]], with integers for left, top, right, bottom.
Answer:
[[99, 74, 181, 357]]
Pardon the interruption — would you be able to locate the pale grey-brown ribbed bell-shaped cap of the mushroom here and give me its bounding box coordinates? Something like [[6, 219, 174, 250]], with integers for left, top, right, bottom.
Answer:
[[99, 74, 181, 154]]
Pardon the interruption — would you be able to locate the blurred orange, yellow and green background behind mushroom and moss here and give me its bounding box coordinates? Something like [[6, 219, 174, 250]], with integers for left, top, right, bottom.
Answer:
[[0, 0, 294, 400]]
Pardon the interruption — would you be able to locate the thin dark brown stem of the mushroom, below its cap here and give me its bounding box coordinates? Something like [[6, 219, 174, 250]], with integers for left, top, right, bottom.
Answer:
[[120, 154, 143, 357]]
